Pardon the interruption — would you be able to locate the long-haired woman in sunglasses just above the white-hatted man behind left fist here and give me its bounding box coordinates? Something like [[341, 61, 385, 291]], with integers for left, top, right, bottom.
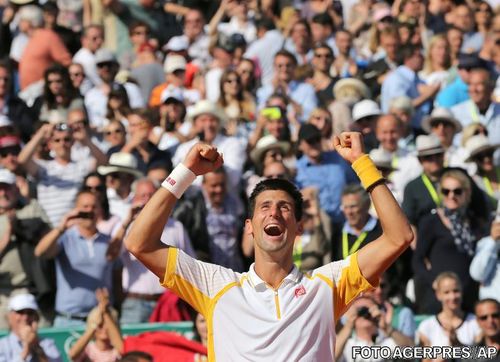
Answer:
[[218, 70, 256, 138]]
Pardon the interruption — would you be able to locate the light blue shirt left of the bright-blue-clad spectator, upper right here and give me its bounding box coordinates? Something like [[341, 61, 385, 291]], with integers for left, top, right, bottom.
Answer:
[[380, 65, 432, 128]]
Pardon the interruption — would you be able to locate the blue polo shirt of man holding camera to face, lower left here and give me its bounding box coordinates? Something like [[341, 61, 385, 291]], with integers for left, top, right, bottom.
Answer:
[[55, 226, 116, 316]]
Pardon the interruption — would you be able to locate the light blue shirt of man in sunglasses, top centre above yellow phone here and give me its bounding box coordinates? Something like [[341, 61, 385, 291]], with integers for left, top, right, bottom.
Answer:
[[257, 80, 318, 122]]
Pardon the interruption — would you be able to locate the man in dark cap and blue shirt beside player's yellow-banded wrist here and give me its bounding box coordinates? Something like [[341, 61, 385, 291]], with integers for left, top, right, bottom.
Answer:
[[295, 124, 359, 223]]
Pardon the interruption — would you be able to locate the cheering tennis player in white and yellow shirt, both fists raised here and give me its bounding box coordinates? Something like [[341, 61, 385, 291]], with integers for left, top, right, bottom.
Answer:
[[125, 132, 413, 361]]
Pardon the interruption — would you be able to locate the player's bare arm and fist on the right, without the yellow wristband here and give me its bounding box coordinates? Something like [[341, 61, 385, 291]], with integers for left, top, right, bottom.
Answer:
[[334, 132, 413, 285]]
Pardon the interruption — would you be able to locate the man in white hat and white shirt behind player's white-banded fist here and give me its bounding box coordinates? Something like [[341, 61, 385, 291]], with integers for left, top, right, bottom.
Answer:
[[172, 100, 246, 197]]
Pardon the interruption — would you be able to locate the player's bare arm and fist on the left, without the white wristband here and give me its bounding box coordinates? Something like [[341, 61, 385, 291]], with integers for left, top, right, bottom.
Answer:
[[124, 143, 223, 278]]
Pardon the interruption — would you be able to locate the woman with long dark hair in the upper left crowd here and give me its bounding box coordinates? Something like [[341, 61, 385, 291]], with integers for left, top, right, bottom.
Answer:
[[32, 64, 84, 122]]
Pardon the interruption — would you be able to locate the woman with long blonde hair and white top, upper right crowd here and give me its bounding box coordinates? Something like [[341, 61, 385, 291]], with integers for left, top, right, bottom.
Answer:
[[419, 34, 451, 88]]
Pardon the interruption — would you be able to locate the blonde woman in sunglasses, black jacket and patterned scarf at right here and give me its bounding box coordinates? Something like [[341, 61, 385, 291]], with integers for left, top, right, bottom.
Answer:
[[413, 170, 484, 314]]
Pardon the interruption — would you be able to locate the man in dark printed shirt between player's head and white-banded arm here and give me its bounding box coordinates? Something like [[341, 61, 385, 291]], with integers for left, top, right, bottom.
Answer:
[[201, 168, 244, 271]]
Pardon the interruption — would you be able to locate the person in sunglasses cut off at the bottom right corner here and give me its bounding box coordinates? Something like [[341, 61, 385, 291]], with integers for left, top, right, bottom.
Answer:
[[475, 299, 500, 357]]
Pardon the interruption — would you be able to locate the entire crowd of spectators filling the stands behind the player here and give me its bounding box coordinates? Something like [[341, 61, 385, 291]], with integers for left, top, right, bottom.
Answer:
[[0, 0, 500, 361]]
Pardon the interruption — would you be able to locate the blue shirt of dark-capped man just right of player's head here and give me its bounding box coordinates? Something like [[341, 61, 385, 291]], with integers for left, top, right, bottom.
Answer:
[[295, 151, 359, 223]]
